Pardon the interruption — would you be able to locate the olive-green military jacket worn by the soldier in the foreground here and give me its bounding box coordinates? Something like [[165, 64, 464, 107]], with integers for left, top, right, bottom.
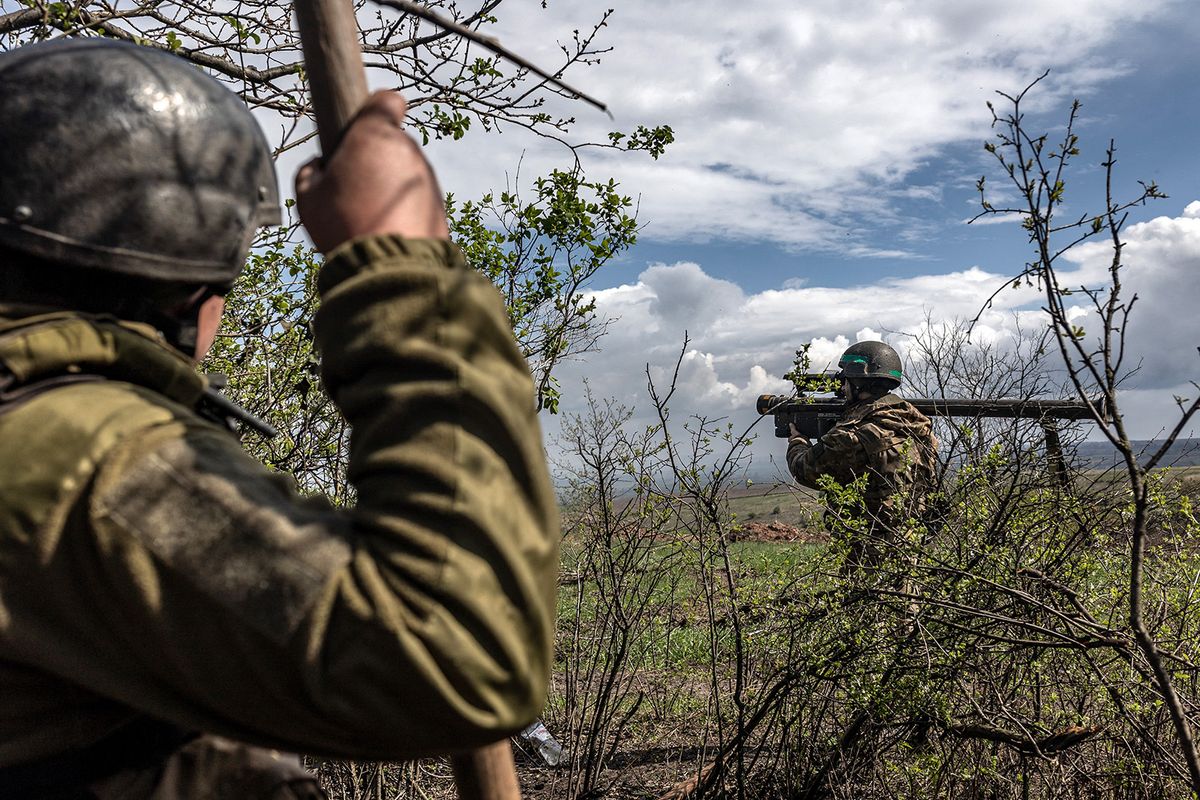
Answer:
[[0, 237, 559, 798]]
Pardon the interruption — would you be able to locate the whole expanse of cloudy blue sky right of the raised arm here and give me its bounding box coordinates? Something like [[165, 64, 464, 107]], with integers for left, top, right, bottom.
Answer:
[[422, 0, 1200, 470]]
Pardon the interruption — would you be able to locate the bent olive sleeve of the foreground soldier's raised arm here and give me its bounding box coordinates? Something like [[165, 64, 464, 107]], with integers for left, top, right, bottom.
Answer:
[[73, 237, 559, 759]]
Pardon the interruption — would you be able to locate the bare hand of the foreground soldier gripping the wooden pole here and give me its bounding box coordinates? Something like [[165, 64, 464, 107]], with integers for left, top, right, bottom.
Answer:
[[296, 91, 450, 253]]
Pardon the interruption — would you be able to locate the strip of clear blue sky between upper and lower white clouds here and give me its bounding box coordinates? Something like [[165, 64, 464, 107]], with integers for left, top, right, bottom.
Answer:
[[609, 36, 1200, 291]]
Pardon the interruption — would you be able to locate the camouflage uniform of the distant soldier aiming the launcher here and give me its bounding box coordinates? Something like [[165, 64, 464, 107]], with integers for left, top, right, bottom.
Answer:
[[787, 393, 937, 566]]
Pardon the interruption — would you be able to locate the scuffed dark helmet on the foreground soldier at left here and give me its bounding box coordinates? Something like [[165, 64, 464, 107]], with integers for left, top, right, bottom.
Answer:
[[0, 38, 280, 287]]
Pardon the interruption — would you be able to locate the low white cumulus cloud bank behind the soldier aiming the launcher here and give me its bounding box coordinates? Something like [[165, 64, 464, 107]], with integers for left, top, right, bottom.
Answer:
[[551, 203, 1200, 470]]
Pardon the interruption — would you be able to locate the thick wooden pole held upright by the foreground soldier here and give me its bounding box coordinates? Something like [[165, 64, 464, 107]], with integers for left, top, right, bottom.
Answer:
[[295, 0, 521, 800]]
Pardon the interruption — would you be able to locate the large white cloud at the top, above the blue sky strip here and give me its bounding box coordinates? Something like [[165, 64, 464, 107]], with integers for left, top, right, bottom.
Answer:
[[434, 0, 1186, 250]]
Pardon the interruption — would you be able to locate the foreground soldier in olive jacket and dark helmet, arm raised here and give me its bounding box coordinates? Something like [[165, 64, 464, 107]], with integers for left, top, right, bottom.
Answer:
[[0, 35, 558, 796]]
